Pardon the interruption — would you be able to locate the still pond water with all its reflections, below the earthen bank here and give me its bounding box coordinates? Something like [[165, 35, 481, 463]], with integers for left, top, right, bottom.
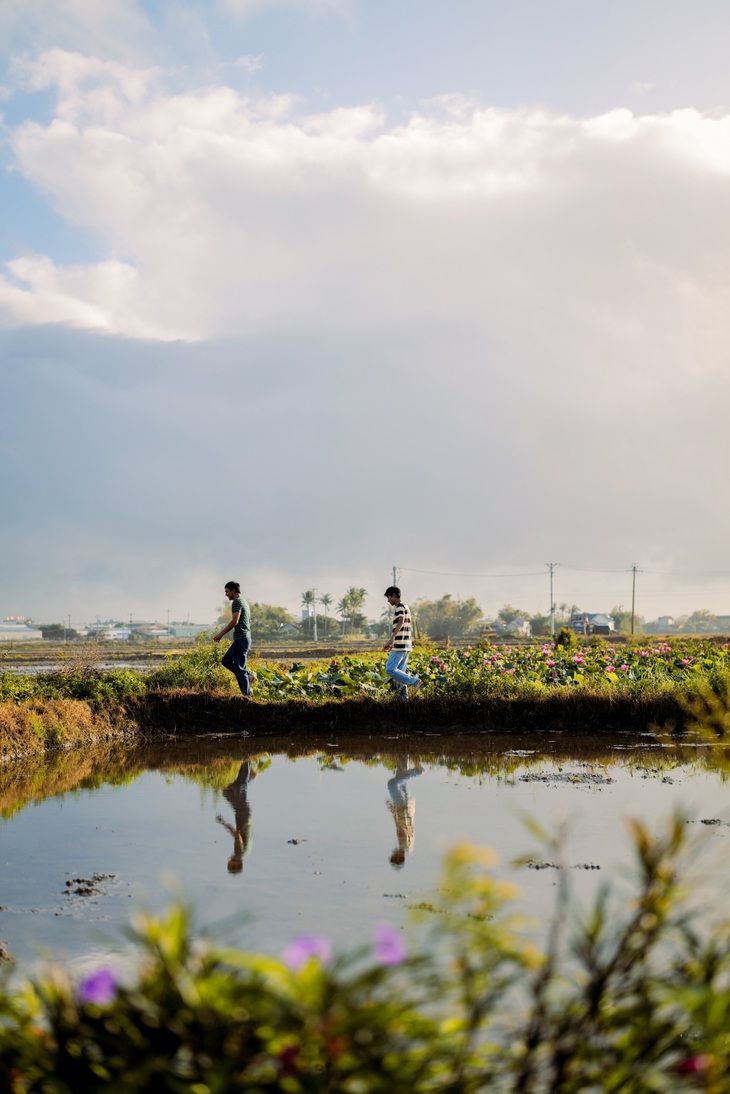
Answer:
[[0, 734, 730, 973]]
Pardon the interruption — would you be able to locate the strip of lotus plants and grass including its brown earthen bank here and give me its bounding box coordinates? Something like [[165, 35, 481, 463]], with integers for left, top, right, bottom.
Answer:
[[0, 631, 730, 759]]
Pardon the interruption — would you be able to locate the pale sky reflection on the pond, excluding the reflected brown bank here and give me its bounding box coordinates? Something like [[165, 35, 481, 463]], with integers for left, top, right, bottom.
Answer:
[[0, 746, 730, 980]]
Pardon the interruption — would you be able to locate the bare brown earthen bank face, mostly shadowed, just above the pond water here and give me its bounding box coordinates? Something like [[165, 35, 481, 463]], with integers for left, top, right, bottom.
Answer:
[[0, 690, 709, 758]]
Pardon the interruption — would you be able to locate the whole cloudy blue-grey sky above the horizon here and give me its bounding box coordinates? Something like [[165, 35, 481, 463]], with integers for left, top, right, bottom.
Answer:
[[0, 0, 730, 625]]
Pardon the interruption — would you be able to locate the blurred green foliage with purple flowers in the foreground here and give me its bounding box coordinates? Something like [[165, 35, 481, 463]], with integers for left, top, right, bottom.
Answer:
[[0, 816, 730, 1094]]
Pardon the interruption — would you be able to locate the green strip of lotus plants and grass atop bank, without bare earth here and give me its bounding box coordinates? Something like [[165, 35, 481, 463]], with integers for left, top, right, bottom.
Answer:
[[0, 627, 730, 702]]
